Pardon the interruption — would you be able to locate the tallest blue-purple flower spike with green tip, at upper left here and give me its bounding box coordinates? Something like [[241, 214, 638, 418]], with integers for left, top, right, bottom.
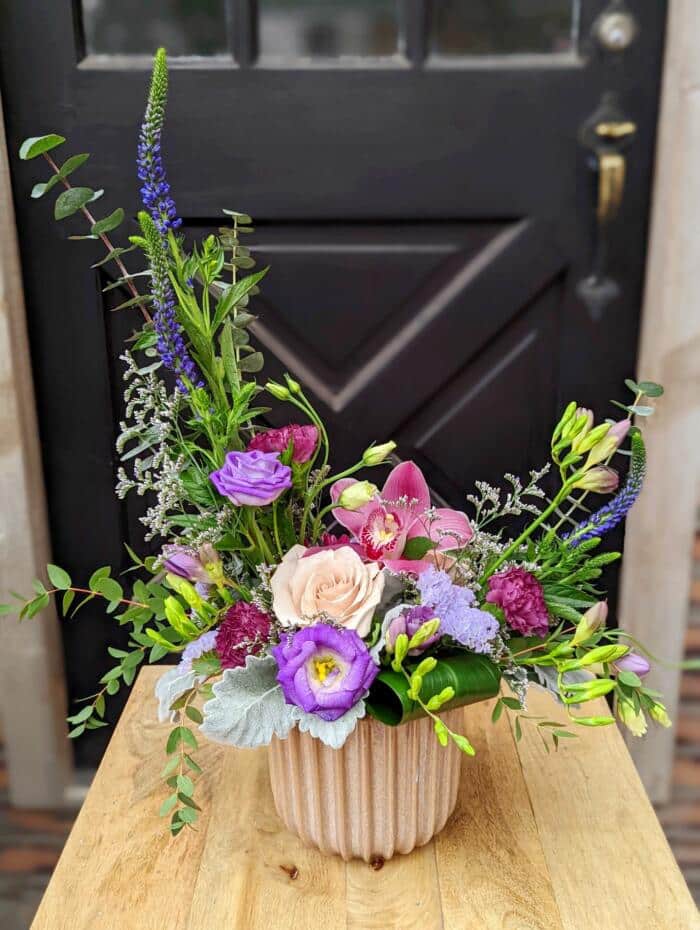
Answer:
[[136, 48, 182, 236]]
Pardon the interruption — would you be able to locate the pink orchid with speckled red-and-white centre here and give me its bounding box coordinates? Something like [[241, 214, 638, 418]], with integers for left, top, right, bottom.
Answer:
[[331, 462, 474, 574]]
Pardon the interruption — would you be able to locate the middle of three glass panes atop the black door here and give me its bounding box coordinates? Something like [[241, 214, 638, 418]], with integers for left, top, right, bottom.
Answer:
[[258, 0, 398, 59]]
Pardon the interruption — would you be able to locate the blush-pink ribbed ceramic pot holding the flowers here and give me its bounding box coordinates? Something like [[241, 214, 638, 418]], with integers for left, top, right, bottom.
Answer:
[[268, 708, 463, 862]]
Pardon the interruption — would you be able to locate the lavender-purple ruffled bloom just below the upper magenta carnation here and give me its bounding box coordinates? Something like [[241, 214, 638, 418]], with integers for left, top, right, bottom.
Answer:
[[209, 450, 292, 507]]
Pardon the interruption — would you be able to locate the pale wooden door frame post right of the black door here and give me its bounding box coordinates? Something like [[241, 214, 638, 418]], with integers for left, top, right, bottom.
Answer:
[[620, 0, 700, 802]]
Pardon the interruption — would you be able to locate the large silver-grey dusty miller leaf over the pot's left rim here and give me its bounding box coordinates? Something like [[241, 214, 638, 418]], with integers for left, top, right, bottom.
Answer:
[[199, 655, 294, 749]]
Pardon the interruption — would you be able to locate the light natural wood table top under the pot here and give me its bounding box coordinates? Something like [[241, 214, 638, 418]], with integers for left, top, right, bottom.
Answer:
[[32, 669, 700, 930]]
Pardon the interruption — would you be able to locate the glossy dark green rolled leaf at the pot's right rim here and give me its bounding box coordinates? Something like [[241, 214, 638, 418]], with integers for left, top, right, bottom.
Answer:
[[365, 652, 501, 727]]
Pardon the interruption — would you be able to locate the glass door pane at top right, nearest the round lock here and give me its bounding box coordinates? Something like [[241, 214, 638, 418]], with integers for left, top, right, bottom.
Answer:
[[432, 0, 579, 56]]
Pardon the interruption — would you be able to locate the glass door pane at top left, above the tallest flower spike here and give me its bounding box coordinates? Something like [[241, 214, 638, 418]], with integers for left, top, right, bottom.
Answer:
[[82, 0, 227, 56]]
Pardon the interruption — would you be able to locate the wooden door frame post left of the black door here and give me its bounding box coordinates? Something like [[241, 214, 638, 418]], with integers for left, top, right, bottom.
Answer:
[[0, 87, 72, 808]]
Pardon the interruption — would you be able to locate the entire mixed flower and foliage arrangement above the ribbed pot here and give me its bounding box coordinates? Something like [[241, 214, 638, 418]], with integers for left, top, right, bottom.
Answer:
[[2, 50, 669, 835]]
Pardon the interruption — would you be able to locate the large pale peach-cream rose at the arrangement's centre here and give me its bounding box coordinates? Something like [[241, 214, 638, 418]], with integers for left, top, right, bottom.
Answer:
[[271, 546, 384, 636]]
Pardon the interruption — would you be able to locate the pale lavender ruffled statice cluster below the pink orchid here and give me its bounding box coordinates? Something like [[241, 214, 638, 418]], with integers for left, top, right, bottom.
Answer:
[[417, 565, 499, 653]]
